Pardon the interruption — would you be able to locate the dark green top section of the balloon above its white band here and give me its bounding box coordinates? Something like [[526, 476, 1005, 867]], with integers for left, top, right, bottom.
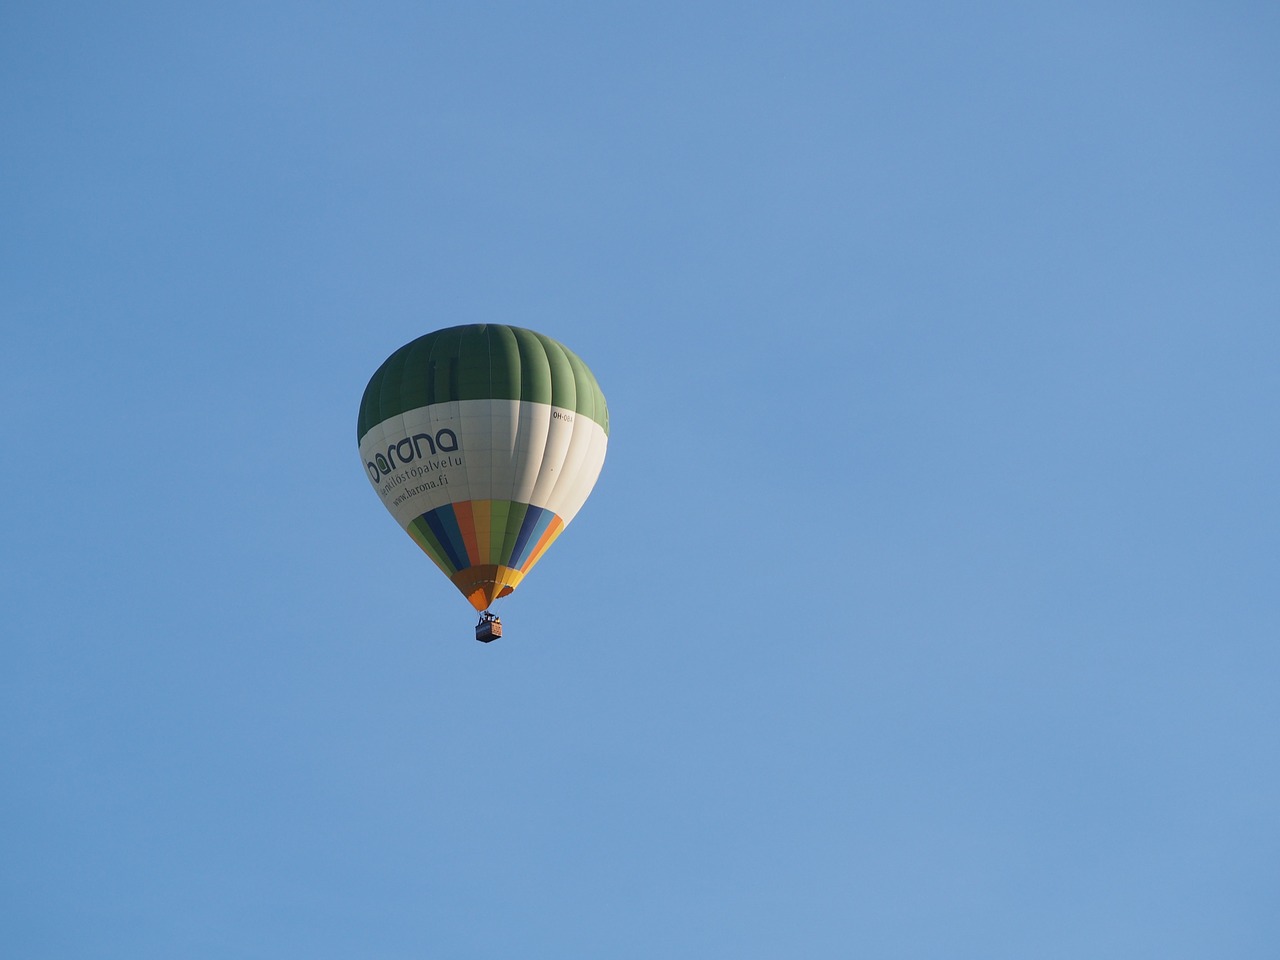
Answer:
[[356, 324, 609, 440]]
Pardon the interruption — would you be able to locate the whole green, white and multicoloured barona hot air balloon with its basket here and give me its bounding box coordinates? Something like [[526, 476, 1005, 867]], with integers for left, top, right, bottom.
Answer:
[[356, 324, 609, 641]]
